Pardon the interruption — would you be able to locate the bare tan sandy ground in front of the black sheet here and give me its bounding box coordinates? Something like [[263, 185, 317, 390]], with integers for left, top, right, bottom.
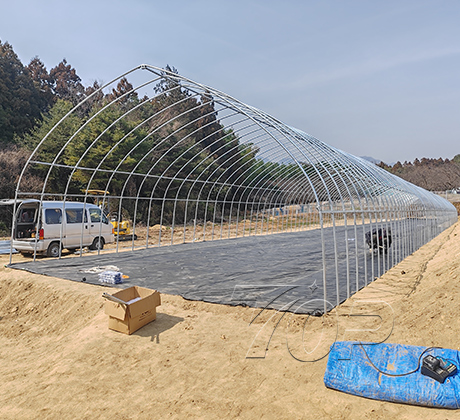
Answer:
[[0, 223, 460, 419]]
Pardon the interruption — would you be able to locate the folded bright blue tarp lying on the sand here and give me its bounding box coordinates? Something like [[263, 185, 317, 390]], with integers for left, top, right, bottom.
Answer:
[[324, 341, 460, 409]]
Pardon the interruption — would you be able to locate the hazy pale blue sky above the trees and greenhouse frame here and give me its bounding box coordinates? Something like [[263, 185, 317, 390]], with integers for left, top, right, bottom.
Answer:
[[0, 0, 460, 163]]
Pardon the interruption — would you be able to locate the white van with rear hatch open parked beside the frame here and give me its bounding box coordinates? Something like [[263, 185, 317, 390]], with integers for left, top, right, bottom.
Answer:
[[13, 200, 114, 257]]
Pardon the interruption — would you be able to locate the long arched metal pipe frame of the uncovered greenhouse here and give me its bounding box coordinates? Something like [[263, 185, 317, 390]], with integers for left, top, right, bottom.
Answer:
[[10, 64, 457, 311]]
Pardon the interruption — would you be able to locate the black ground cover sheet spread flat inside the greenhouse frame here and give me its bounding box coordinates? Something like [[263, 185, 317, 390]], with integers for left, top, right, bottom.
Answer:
[[11, 221, 406, 313]]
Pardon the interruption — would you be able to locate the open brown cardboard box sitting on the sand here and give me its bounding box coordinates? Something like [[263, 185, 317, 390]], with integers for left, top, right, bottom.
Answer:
[[105, 286, 161, 334]]
